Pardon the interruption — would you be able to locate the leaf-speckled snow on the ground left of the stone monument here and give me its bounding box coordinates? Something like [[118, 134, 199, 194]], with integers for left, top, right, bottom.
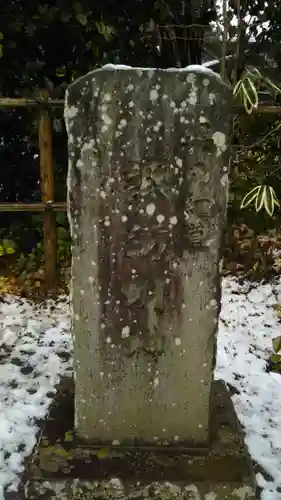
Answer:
[[0, 296, 71, 500]]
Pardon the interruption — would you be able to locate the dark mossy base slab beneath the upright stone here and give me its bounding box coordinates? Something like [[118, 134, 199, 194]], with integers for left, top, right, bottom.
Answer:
[[19, 379, 258, 500]]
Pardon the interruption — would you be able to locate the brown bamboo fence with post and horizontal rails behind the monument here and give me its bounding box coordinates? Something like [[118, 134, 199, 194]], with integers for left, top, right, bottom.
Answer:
[[0, 94, 281, 287]]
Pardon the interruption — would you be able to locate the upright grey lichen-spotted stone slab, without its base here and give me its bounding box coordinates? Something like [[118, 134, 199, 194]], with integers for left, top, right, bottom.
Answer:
[[65, 67, 230, 445]]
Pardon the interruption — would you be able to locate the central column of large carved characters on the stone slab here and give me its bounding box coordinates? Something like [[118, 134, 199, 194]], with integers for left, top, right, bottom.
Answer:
[[102, 159, 182, 356]]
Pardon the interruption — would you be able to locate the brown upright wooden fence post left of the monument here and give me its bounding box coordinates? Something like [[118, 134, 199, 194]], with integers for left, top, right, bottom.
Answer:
[[38, 90, 57, 287]]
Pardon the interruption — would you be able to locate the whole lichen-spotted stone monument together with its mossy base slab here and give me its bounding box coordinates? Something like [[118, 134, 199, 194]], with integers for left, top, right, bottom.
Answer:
[[25, 66, 255, 500]]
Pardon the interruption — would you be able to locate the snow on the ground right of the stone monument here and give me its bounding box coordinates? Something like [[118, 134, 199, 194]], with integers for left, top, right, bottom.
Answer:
[[216, 280, 281, 500]]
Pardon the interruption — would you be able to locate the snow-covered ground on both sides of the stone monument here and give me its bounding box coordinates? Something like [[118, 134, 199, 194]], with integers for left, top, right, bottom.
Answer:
[[0, 279, 281, 500]]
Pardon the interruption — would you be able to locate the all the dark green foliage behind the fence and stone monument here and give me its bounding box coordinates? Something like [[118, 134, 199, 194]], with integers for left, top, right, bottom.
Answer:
[[0, 0, 281, 280]]
